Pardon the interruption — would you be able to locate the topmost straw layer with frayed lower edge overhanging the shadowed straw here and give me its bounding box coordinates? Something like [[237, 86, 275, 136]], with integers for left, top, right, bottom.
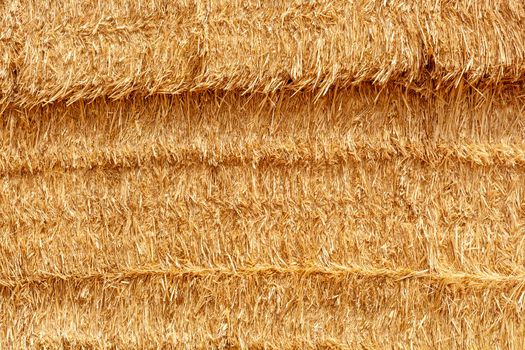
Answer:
[[0, 0, 525, 106]]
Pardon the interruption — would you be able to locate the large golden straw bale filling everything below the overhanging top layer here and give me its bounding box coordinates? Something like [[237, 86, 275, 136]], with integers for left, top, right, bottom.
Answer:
[[0, 86, 525, 348]]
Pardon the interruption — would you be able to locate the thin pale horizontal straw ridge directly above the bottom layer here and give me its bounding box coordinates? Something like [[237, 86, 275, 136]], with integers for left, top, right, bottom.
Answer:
[[4, 265, 525, 289]]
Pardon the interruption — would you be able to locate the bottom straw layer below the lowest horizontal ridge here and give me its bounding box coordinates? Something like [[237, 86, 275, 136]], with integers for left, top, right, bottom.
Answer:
[[0, 267, 524, 348]]
